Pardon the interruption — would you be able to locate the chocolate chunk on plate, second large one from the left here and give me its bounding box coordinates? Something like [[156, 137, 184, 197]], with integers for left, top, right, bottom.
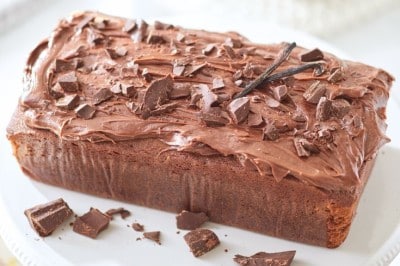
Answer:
[[73, 208, 110, 238]]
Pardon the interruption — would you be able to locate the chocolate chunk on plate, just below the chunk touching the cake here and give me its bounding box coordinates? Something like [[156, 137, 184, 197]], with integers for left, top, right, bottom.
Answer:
[[183, 228, 219, 257]]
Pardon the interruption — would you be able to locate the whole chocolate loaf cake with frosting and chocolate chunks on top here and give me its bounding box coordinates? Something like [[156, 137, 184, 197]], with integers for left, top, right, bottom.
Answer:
[[7, 12, 393, 248]]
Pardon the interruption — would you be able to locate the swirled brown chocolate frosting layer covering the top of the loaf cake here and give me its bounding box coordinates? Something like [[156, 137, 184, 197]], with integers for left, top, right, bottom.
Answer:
[[20, 12, 393, 191]]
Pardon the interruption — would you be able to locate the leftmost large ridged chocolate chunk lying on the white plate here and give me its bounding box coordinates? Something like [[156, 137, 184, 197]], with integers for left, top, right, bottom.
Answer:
[[24, 199, 73, 236]]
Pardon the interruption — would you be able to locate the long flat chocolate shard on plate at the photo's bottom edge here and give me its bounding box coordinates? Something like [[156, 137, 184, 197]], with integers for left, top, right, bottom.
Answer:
[[233, 250, 296, 266]]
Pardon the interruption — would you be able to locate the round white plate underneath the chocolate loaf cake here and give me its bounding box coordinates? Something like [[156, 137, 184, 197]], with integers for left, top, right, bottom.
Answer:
[[0, 13, 400, 266]]
